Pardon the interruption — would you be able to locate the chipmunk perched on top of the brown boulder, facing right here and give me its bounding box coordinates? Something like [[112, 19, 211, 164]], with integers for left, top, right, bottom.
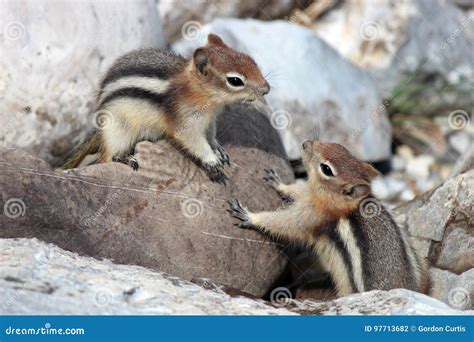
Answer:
[[63, 34, 270, 181]]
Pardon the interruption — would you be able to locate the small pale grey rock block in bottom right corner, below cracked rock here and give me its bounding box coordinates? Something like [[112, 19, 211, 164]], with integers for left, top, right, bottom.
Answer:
[[430, 268, 474, 310]]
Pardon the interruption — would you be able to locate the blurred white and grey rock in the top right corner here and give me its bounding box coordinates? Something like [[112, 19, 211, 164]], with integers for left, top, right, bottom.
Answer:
[[314, 0, 474, 101]]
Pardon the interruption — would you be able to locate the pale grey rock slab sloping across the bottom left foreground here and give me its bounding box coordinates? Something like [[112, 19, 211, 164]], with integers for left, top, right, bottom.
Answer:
[[0, 239, 292, 315]]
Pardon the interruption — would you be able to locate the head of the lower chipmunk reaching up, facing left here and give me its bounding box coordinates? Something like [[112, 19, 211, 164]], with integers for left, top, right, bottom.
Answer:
[[303, 140, 379, 216]]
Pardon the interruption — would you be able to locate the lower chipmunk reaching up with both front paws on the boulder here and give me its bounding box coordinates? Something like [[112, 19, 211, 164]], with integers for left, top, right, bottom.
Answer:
[[228, 141, 428, 296]]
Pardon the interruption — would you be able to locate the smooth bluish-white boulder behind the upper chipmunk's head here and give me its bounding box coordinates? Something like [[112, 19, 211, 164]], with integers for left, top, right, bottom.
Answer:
[[173, 19, 391, 161]]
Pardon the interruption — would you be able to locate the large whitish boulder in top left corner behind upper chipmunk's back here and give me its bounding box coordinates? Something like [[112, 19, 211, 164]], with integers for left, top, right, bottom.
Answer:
[[0, 0, 165, 161]]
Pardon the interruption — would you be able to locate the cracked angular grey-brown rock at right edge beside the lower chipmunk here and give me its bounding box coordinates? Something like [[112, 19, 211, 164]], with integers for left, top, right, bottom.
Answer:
[[394, 170, 474, 307]]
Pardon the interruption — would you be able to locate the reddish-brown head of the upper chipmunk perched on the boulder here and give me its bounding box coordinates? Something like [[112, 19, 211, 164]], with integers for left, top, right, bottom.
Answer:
[[193, 33, 270, 103]]
